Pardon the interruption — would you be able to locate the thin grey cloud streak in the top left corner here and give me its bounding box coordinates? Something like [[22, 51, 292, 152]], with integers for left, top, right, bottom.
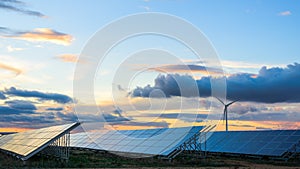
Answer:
[[0, 0, 46, 17]]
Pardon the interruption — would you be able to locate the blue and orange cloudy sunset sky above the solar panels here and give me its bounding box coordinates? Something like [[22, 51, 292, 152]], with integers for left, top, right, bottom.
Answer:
[[0, 0, 300, 131]]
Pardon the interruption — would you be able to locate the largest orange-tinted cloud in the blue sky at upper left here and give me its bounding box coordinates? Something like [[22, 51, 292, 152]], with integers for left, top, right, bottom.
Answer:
[[6, 28, 73, 45]]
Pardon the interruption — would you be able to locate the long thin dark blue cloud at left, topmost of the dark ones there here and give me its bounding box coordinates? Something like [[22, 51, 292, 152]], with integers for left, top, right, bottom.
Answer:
[[4, 87, 72, 104]]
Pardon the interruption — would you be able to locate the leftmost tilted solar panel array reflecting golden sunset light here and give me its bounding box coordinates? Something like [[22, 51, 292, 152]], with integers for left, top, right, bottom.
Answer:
[[0, 123, 79, 160]]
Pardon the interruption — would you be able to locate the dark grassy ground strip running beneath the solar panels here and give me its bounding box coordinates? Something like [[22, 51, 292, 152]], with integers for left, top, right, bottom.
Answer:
[[0, 150, 300, 169]]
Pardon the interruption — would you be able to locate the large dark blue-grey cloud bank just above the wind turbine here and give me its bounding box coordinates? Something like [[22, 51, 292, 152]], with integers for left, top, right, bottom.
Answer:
[[130, 63, 300, 103]]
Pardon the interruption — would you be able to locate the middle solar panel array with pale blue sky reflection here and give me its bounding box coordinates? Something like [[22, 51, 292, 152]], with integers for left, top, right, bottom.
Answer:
[[70, 126, 203, 156]]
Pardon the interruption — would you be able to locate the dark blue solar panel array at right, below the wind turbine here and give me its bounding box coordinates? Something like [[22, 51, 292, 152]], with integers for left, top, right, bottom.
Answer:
[[202, 130, 300, 156]]
